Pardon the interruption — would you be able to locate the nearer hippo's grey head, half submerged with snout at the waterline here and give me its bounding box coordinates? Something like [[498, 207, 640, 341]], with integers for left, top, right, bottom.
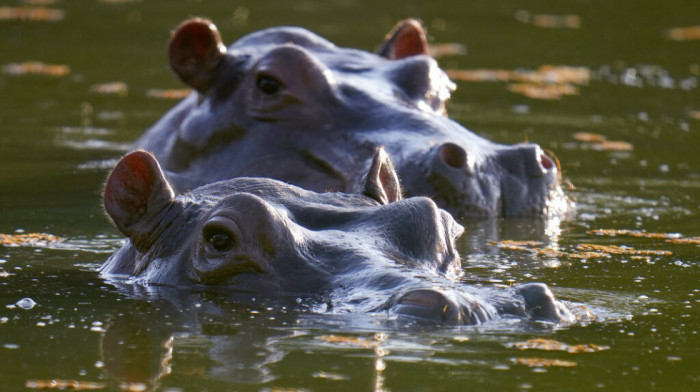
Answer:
[[100, 149, 574, 324]]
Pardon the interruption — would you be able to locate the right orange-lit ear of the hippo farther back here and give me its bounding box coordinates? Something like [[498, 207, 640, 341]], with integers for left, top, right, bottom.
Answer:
[[378, 19, 428, 60]]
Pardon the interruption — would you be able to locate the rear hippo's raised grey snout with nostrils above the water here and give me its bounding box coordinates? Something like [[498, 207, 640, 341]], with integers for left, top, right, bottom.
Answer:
[[400, 141, 560, 218]]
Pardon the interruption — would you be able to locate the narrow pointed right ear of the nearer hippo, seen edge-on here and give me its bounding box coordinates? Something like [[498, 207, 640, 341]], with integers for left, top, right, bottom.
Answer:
[[362, 147, 402, 204]]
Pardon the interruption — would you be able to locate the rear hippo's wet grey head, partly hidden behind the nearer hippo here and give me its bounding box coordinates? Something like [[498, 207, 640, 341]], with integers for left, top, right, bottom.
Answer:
[[135, 19, 572, 218]]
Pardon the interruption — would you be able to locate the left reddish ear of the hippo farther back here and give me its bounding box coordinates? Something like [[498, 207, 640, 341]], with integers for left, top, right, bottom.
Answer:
[[168, 18, 226, 93]]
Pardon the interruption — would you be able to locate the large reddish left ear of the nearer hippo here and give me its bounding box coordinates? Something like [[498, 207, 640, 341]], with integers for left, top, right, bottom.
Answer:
[[104, 151, 175, 252]]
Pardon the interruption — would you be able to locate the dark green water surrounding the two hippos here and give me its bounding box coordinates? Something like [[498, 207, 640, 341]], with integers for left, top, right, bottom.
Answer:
[[0, 0, 700, 391]]
